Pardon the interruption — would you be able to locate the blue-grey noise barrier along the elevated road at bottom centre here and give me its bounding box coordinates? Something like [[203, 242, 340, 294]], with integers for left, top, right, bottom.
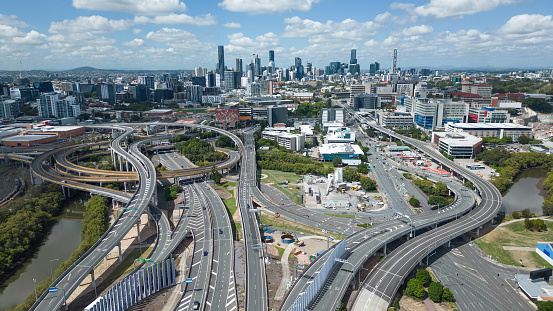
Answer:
[[288, 239, 346, 311]]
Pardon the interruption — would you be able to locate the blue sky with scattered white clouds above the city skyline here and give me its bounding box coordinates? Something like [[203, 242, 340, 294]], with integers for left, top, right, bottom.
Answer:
[[0, 0, 553, 70]]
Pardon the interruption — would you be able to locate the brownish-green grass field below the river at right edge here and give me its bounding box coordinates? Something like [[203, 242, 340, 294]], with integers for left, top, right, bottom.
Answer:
[[478, 220, 553, 268]]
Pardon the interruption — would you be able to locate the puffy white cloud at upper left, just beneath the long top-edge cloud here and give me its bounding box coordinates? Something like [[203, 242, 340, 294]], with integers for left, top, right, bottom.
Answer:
[[48, 15, 132, 33]]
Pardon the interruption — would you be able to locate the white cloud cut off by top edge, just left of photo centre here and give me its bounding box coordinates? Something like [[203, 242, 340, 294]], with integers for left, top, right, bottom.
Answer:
[[218, 0, 321, 14]]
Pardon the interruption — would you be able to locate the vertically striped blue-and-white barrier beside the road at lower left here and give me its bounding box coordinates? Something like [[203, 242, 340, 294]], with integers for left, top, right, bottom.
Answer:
[[85, 258, 175, 311]]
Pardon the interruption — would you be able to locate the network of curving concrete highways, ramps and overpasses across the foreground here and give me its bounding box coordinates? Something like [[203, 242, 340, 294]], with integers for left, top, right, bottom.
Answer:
[[1, 120, 529, 311]]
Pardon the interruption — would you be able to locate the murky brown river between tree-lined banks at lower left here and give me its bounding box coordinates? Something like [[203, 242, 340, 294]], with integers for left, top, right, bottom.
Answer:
[[0, 198, 86, 310]]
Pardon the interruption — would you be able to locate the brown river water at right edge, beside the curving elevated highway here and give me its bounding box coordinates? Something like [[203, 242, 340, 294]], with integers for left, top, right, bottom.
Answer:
[[501, 168, 549, 215]]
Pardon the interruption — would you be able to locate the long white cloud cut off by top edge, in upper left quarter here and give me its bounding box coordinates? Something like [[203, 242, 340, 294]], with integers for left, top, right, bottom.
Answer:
[[73, 0, 186, 15]]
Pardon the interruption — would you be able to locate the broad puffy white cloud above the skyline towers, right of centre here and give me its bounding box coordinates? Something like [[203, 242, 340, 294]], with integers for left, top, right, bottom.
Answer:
[[282, 16, 380, 43]]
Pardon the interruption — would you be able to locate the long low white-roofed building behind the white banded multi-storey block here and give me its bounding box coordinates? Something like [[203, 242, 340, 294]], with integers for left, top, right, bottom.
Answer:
[[445, 123, 533, 141]]
